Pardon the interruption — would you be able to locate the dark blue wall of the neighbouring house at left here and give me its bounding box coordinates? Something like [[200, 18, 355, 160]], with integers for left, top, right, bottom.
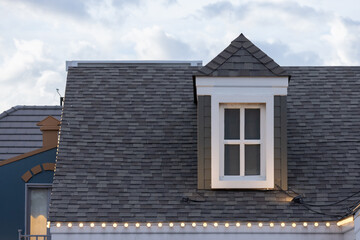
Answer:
[[0, 148, 56, 240]]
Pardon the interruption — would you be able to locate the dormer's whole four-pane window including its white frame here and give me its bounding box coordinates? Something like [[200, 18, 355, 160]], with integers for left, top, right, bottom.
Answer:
[[211, 94, 274, 189]]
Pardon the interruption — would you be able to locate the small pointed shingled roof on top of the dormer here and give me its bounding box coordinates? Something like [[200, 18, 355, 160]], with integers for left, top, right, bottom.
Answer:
[[196, 34, 289, 77]]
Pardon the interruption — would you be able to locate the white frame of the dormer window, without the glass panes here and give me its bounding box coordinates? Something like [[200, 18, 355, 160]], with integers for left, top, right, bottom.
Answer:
[[211, 92, 274, 189]]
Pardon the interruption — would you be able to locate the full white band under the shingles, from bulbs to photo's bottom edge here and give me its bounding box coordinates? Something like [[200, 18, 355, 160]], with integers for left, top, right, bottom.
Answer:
[[50, 222, 354, 240]]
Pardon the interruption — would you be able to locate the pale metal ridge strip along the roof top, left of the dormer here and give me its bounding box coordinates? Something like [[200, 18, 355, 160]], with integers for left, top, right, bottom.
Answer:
[[66, 60, 202, 71]]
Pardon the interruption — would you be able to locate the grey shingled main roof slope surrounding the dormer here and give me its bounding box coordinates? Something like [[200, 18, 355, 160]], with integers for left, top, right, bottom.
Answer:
[[50, 64, 360, 222]]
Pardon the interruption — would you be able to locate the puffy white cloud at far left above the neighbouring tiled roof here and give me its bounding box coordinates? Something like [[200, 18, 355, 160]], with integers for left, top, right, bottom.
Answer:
[[0, 40, 64, 111]]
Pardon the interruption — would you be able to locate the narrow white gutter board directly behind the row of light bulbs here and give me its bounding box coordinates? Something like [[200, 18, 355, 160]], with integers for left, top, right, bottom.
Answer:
[[51, 222, 346, 234]]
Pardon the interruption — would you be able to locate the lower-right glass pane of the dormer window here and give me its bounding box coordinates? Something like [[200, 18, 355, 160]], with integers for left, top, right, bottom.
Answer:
[[245, 144, 260, 176]]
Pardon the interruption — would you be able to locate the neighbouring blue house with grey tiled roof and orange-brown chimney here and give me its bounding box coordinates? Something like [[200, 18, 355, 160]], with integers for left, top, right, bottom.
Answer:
[[0, 106, 61, 240]]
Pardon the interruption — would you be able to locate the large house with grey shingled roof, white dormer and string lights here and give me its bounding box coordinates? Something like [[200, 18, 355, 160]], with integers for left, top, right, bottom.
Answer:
[[49, 34, 360, 240]]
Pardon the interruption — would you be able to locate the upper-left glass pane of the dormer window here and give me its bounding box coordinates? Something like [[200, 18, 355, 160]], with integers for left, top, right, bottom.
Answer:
[[224, 109, 240, 139]]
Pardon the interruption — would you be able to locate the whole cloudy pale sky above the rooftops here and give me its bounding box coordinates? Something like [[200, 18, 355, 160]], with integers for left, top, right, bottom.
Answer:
[[0, 0, 360, 113]]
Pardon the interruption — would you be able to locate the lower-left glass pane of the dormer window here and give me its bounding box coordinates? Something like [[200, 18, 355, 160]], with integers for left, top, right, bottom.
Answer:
[[225, 144, 240, 175]]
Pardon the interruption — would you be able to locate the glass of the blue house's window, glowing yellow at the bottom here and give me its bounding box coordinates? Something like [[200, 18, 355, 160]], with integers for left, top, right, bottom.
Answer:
[[30, 188, 49, 235]]
